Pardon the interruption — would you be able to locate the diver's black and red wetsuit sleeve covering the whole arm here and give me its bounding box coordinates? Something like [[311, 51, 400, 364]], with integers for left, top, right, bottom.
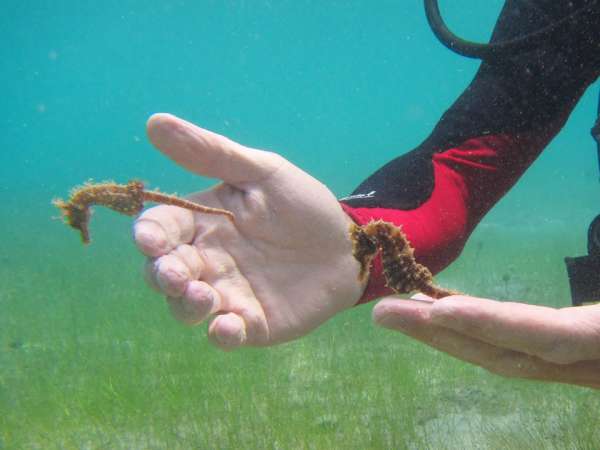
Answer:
[[340, 0, 600, 302]]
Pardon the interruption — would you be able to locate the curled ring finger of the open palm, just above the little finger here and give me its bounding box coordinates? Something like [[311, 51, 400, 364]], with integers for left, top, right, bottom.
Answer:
[[168, 280, 221, 325]]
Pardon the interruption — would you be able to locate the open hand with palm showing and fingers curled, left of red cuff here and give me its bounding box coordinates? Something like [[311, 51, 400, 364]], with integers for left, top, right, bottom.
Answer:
[[134, 114, 364, 350]]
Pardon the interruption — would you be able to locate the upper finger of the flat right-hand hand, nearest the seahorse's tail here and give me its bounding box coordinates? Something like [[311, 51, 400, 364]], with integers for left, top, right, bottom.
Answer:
[[431, 296, 600, 364]]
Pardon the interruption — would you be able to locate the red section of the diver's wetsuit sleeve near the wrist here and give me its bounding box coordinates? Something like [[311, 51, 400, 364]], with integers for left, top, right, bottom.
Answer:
[[341, 135, 564, 303]]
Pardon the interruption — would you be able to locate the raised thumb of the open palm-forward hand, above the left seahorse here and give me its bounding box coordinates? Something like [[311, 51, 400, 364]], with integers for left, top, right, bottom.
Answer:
[[147, 114, 284, 186]]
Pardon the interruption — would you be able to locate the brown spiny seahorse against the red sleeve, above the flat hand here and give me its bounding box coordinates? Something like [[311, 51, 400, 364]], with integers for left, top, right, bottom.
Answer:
[[350, 220, 457, 298]]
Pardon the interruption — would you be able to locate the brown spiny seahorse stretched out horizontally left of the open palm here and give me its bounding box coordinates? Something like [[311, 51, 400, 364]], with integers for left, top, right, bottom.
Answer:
[[53, 180, 234, 244]]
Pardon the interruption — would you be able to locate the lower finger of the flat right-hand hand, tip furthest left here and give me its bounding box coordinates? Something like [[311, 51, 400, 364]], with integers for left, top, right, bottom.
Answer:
[[373, 299, 600, 387]]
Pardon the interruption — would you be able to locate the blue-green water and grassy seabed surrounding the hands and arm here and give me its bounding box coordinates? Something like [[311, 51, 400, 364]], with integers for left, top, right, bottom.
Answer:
[[0, 0, 600, 449]]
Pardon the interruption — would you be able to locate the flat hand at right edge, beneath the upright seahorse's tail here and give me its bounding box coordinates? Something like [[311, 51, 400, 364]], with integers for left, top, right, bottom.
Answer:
[[373, 295, 600, 389]]
